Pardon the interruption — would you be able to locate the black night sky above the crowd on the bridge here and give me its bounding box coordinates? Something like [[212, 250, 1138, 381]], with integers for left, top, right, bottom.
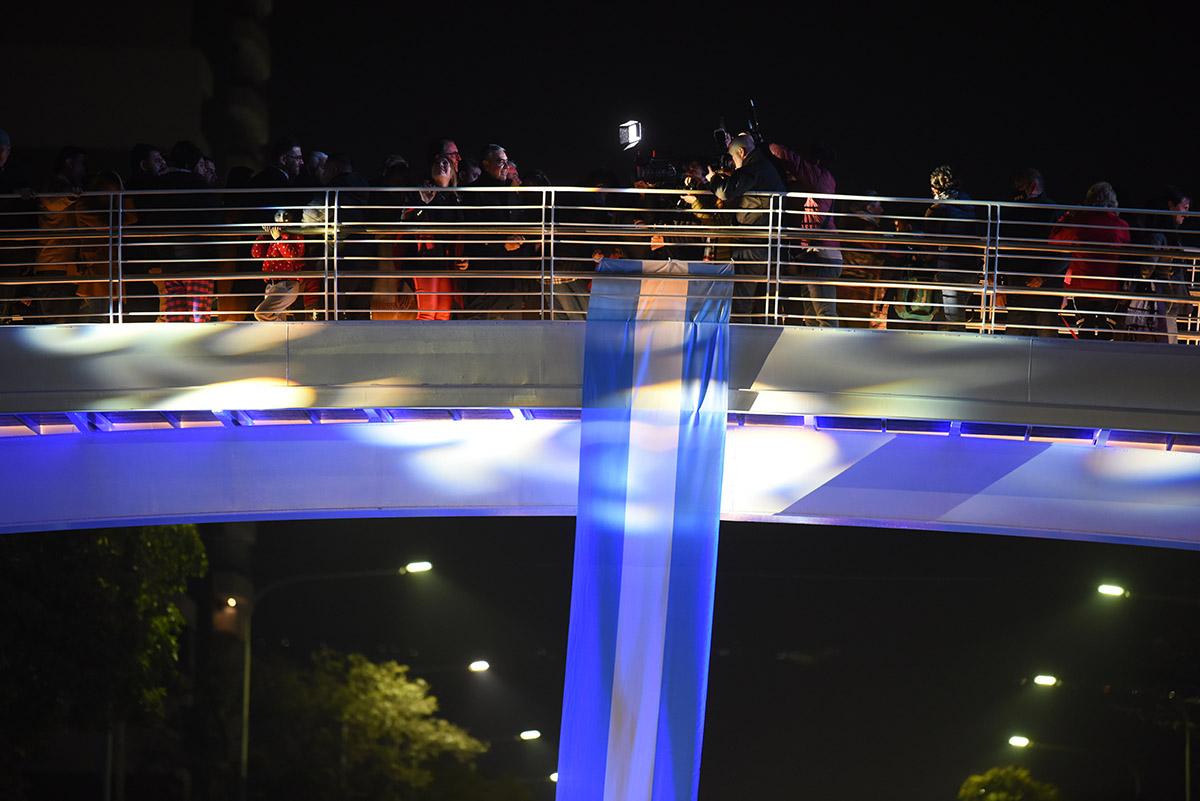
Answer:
[[270, 0, 1198, 205]]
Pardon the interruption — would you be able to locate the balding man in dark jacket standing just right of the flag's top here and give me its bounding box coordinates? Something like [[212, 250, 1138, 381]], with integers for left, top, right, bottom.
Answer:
[[707, 133, 785, 323]]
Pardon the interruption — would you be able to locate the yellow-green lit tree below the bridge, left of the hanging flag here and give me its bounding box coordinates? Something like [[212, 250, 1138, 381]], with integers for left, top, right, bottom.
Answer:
[[251, 650, 486, 800]]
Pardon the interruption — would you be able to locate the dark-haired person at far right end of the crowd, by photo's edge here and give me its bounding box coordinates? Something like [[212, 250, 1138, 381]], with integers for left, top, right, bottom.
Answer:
[[1129, 186, 1192, 345]]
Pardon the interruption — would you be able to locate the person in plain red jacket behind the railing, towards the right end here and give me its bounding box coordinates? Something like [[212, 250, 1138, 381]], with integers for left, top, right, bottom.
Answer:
[[1050, 181, 1129, 339]]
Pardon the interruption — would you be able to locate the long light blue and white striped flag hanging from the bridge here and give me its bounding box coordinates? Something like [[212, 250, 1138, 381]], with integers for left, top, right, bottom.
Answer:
[[558, 259, 732, 801]]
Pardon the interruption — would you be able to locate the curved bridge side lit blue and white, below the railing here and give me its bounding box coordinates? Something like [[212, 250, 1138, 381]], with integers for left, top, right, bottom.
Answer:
[[0, 321, 1200, 548]]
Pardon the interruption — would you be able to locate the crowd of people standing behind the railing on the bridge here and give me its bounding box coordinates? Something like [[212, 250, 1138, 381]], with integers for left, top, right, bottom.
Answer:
[[0, 125, 1195, 342]]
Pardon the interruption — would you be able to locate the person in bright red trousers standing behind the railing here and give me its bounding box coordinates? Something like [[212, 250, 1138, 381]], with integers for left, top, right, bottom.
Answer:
[[403, 152, 467, 320]]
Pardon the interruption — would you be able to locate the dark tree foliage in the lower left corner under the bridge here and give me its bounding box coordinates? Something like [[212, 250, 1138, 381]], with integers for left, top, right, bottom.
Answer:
[[0, 525, 208, 786]]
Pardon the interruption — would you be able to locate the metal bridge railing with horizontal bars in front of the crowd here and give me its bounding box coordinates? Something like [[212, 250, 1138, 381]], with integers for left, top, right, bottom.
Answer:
[[0, 187, 1200, 343]]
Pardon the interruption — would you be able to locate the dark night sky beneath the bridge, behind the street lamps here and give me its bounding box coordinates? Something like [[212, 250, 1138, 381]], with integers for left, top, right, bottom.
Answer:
[[248, 518, 1200, 801]]
